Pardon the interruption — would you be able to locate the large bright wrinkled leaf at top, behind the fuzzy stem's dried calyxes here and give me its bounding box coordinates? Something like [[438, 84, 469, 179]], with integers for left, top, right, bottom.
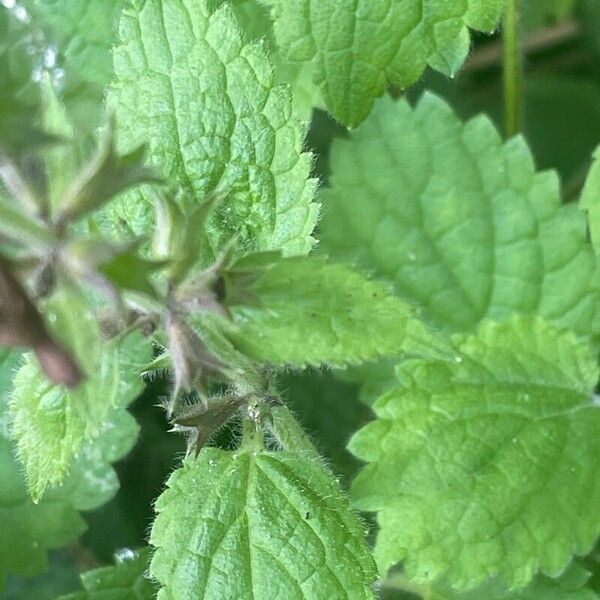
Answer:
[[109, 0, 318, 262]]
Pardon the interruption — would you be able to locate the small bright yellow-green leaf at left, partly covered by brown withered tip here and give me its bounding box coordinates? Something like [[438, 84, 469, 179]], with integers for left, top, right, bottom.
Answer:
[[10, 295, 151, 500]]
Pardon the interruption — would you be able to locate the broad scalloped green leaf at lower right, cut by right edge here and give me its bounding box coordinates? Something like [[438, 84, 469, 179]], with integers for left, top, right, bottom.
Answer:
[[350, 317, 600, 589]]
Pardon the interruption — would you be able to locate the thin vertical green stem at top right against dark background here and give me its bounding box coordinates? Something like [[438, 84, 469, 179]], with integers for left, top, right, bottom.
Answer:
[[503, 0, 523, 137]]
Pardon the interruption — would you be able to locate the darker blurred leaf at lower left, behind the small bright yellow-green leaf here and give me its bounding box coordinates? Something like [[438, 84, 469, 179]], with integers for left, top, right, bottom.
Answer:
[[0, 352, 138, 587]]
